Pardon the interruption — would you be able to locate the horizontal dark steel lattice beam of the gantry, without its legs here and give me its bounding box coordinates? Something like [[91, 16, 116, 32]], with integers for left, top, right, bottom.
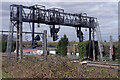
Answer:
[[10, 5, 96, 28]]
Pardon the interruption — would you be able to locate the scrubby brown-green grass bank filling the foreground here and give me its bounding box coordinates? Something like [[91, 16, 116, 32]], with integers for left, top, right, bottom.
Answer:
[[2, 56, 117, 78]]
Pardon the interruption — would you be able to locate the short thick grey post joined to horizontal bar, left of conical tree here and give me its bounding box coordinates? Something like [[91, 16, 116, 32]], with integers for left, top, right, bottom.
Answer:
[[43, 30, 47, 60]]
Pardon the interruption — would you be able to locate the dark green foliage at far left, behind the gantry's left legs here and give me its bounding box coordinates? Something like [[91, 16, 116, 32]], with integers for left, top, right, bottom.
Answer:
[[0, 41, 16, 52]]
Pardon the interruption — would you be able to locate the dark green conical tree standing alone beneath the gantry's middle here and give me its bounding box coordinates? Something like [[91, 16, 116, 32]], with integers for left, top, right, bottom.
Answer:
[[57, 34, 69, 56]]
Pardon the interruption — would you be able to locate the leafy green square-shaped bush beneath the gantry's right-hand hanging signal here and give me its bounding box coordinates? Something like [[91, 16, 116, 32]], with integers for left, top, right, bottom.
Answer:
[[78, 41, 89, 58]]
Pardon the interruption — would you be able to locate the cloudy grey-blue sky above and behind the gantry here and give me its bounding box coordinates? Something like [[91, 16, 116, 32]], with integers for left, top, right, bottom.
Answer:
[[0, 2, 118, 42]]
